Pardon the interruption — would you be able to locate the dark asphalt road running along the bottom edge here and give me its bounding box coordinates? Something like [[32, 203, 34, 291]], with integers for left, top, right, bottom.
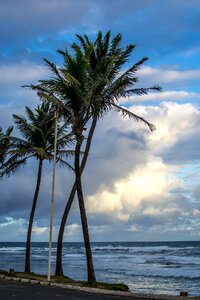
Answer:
[[0, 276, 200, 300]]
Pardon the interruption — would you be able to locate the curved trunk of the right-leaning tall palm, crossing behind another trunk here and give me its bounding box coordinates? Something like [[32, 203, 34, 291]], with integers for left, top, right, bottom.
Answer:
[[55, 117, 97, 276]]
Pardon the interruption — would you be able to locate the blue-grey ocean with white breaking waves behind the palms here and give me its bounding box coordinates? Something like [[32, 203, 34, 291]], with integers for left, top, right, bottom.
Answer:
[[0, 241, 200, 296]]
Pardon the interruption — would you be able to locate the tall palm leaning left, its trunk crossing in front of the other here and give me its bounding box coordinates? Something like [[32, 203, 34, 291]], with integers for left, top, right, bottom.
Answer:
[[27, 49, 99, 283]]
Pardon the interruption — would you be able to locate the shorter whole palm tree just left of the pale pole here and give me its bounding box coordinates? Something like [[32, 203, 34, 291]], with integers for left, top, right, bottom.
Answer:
[[2, 103, 72, 272]]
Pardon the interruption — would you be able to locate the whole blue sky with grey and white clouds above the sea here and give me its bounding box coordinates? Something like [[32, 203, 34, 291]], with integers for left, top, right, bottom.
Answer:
[[0, 0, 200, 242]]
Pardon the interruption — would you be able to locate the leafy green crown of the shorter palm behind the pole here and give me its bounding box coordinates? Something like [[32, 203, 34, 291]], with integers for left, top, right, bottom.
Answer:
[[1, 103, 73, 175]]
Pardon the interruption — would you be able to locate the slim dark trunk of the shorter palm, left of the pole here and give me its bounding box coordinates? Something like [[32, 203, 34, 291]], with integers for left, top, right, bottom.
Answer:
[[24, 159, 43, 272]]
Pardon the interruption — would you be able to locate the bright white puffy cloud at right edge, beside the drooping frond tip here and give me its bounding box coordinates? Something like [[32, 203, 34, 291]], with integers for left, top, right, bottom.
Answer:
[[130, 102, 200, 152]]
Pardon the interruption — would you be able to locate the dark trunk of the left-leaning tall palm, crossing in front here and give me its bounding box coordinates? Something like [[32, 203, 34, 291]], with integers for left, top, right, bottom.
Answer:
[[74, 135, 96, 284]]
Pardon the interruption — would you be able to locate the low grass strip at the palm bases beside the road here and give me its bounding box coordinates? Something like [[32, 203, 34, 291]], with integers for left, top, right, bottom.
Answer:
[[0, 270, 129, 292]]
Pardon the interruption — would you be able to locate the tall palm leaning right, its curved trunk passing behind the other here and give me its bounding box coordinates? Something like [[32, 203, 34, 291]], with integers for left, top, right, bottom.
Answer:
[[56, 31, 161, 275]]
